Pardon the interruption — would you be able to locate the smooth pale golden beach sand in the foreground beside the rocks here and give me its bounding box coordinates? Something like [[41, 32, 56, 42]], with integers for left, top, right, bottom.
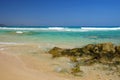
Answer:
[[0, 44, 120, 80]]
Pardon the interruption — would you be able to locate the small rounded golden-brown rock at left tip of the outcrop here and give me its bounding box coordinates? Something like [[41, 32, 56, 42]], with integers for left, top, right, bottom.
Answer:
[[48, 47, 63, 57]]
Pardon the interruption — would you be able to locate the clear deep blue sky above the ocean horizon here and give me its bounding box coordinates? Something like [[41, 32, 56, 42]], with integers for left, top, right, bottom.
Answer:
[[0, 0, 120, 26]]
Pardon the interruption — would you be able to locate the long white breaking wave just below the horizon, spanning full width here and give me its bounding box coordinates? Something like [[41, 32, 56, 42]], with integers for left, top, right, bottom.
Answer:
[[0, 27, 120, 32]]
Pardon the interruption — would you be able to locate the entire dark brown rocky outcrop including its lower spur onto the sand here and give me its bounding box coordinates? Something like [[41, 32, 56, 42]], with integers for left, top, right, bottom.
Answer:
[[49, 43, 120, 76]]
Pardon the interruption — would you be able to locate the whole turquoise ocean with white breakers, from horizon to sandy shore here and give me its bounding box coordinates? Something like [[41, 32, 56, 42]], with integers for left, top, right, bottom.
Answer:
[[0, 26, 120, 47]]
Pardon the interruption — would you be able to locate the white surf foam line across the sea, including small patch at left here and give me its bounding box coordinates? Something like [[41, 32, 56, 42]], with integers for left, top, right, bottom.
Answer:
[[0, 27, 120, 31]]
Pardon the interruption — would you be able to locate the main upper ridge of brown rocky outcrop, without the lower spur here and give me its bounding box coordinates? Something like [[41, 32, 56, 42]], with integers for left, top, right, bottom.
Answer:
[[49, 43, 120, 63]]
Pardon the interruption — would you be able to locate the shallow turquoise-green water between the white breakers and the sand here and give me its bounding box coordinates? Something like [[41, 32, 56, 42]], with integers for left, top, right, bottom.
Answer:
[[0, 30, 120, 46]]
